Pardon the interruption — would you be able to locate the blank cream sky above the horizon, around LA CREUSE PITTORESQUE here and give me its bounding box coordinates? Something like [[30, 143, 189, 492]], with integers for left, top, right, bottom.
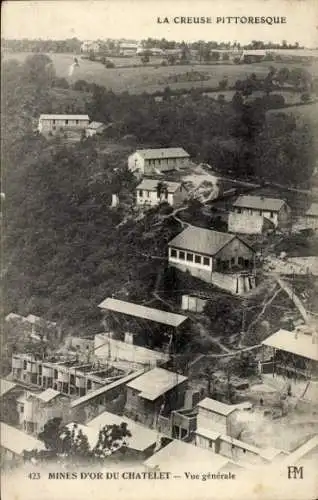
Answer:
[[1, 0, 318, 47]]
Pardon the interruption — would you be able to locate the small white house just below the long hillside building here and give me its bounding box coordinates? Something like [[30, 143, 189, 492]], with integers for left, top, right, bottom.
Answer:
[[136, 179, 187, 206]]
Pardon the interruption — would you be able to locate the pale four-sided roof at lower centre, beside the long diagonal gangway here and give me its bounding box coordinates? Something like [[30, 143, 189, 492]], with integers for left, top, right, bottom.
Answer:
[[127, 368, 188, 401]]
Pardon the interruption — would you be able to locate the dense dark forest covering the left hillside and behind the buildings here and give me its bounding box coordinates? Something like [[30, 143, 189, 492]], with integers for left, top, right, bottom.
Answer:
[[2, 55, 315, 335]]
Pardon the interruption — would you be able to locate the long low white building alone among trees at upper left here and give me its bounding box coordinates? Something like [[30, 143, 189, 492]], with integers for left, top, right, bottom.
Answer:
[[38, 114, 89, 133]]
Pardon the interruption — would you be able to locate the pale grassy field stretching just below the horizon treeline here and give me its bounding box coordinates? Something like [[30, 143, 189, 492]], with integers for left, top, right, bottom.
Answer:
[[4, 53, 318, 94]]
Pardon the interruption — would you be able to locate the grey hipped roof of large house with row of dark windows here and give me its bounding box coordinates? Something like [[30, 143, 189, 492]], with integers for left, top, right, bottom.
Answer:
[[168, 226, 236, 255]]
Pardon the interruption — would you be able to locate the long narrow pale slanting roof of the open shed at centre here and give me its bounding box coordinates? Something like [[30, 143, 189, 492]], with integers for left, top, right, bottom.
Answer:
[[98, 297, 188, 327]]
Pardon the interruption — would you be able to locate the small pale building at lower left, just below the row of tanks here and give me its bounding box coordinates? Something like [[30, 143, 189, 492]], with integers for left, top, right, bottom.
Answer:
[[17, 389, 69, 434]]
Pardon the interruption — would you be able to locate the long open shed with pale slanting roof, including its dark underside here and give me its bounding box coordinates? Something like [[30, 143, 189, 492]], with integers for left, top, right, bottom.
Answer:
[[96, 297, 189, 356]]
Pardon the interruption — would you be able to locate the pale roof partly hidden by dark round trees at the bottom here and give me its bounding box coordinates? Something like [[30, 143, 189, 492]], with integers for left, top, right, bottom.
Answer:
[[86, 411, 158, 451]]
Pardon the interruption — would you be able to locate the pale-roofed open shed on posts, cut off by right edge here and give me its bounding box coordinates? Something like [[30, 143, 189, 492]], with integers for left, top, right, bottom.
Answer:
[[262, 329, 318, 381]]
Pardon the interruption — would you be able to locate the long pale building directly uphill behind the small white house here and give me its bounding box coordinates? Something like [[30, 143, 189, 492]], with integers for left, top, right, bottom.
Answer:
[[128, 148, 190, 175]]
